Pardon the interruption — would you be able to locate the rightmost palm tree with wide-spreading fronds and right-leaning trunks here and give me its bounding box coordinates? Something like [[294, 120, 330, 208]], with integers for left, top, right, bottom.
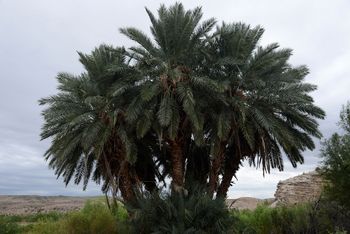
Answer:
[[203, 23, 324, 196]]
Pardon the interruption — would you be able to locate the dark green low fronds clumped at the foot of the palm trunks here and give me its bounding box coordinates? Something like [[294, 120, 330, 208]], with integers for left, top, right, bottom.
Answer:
[[129, 190, 232, 234]]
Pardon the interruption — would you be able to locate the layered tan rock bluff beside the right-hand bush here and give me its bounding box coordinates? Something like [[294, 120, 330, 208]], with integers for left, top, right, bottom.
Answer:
[[275, 171, 323, 204]]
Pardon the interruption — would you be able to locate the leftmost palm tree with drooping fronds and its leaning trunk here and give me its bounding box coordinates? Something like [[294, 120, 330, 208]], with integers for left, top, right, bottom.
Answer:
[[40, 45, 142, 200]]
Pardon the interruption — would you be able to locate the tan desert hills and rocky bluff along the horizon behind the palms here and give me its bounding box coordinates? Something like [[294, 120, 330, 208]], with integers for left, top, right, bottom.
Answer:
[[0, 171, 322, 215]]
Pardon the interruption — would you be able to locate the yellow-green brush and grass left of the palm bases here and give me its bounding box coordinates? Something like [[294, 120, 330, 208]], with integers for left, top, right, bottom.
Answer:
[[0, 199, 129, 234]]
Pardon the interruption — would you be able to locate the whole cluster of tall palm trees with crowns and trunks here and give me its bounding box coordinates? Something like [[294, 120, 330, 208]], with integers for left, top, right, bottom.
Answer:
[[40, 3, 324, 202]]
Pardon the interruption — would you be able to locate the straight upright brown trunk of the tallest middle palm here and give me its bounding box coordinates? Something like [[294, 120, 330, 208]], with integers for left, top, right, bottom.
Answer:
[[169, 140, 184, 192]]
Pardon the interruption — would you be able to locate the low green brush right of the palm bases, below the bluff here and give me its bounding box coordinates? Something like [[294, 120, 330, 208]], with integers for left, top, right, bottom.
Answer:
[[231, 199, 350, 234]]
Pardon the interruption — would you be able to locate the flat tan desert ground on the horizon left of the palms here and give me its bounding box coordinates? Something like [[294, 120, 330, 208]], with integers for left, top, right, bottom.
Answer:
[[0, 195, 93, 215]]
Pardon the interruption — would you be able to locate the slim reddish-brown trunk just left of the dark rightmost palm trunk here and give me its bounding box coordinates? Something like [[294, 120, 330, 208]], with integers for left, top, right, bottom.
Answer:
[[209, 142, 226, 197]]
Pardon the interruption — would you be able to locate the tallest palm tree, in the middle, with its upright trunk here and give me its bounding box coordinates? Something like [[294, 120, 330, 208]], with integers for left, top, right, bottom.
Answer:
[[121, 3, 219, 191]]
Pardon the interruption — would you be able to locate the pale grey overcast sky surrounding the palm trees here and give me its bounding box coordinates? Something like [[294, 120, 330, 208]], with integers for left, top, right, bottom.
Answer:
[[0, 0, 350, 198]]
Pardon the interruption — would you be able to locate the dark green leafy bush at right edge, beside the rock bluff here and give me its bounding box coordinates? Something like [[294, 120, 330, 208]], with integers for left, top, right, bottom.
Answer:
[[322, 103, 350, 209]]
